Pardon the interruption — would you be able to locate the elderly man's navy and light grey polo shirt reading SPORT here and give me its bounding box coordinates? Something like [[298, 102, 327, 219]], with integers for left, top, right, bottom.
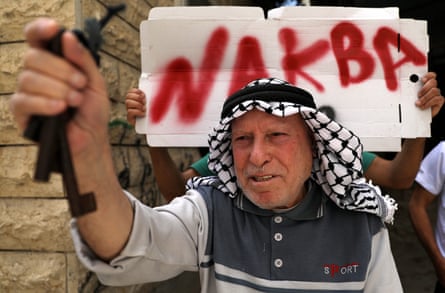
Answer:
[[72, 179, 402, 293]]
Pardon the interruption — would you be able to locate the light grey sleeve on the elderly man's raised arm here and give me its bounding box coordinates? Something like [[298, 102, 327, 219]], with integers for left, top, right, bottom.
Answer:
[[71, 191, 208, 286]]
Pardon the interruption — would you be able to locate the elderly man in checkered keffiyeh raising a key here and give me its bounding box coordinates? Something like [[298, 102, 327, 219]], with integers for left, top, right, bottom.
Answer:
[[11, 19, 402, 292]]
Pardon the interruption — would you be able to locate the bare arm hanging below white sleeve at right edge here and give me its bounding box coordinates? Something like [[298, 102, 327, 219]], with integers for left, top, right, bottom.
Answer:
[[409, 183, 445, 284]]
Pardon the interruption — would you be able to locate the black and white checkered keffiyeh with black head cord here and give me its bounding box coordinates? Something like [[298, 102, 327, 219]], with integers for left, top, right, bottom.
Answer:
[[188, 78, 397, 223]]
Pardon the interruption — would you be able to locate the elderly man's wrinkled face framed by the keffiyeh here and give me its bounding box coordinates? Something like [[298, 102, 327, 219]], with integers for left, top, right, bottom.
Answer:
[[232, 110, 312, 209]]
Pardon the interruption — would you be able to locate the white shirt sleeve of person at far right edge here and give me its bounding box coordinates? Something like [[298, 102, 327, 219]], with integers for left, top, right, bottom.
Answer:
[[416, 142, 445, 195]]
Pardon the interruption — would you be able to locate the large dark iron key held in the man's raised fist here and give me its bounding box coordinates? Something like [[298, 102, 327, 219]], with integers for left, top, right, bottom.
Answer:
[[23, 4, 125, 217]]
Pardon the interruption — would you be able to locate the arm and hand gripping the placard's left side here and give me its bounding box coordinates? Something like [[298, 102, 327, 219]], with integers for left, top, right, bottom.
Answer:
[[125, 88, 199, 202]]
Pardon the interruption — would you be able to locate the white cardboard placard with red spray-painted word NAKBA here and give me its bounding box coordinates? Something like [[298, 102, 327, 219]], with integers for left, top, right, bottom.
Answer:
[[136, 6, 431, 151]]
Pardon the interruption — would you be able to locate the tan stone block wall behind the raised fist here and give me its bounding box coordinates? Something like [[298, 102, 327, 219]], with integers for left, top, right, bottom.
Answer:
[[0, 0, 199, 293]]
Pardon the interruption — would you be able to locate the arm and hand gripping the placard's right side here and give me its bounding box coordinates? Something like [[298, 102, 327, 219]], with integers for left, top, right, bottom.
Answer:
[[364, 72, 444, 189]]
